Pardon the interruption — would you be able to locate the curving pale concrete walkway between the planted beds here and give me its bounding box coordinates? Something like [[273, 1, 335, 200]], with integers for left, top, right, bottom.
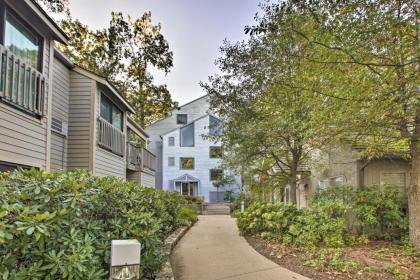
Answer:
[[171, 215, 309, 280]]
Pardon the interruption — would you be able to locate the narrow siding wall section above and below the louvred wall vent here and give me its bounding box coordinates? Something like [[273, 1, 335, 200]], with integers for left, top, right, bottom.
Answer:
[[51, 59, 70, 170]]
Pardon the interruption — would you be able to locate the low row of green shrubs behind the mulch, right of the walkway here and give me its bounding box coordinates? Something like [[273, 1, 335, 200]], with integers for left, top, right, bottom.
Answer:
[[236, 186, 408, 249]]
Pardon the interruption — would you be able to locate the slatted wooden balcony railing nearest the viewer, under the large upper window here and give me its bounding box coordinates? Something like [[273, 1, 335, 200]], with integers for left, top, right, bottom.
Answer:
[[0, 45, 46, 116]]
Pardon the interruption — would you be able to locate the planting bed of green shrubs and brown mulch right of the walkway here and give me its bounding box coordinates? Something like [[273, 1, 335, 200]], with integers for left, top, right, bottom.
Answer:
[[236, 186, 420, 279]]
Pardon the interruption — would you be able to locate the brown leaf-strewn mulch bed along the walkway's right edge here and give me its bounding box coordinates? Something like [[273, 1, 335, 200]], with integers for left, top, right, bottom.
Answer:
[[245, 236, 420, 280]]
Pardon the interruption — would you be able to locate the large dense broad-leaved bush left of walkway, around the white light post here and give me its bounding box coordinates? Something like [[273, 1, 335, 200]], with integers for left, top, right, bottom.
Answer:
[[0, 170, 186, 279]]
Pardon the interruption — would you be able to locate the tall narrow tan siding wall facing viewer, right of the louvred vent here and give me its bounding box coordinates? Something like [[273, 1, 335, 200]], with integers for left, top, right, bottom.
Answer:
[[67, 71, 92, 170]]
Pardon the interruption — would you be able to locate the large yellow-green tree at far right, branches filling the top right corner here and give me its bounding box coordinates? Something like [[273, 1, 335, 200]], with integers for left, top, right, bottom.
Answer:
[[250, 0, 420, 245]]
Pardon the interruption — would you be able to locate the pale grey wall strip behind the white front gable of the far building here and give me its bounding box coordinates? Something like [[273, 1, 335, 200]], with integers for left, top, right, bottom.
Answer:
[[145, 95, 210, 189]]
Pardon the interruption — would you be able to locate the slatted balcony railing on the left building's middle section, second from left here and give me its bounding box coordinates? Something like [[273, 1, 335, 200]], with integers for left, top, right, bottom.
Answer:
[[98, 117, 125, 156]]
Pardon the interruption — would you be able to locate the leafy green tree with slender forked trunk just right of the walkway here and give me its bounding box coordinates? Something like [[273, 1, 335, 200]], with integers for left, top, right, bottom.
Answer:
[[204, 11, 333, 202]]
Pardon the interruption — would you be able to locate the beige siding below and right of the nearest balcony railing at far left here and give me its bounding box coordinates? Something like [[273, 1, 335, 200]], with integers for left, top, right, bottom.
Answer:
[[0, 36, 50, 169]]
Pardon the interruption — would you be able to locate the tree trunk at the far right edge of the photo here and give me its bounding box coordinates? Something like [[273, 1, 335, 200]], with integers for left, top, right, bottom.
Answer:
[[408, 106, 420, 247]]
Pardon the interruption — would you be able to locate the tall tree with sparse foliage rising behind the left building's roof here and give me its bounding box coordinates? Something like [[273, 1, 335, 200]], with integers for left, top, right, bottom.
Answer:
[[62, 12, 177, 126]]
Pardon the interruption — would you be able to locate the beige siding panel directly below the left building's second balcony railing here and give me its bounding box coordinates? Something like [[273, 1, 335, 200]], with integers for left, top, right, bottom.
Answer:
[[94, 147, 126, 178]]
